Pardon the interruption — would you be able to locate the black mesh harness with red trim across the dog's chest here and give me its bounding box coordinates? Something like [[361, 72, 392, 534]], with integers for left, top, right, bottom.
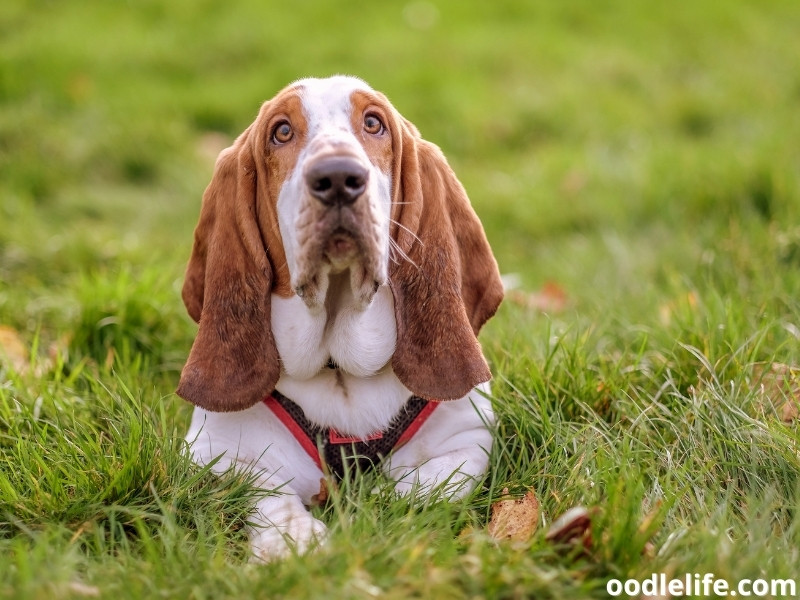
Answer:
[[264, 390, 438, 479]]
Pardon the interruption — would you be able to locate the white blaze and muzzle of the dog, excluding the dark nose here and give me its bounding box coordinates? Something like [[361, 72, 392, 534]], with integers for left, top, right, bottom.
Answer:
[[277, 76, 391, 309]]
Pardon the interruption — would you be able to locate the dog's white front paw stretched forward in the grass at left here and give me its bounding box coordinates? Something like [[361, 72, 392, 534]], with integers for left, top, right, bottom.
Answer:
[[250, 515, 328, 562]]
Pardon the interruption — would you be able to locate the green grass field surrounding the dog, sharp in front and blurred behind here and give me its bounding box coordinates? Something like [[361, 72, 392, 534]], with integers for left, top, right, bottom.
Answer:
[[0, 0, 800, 600]]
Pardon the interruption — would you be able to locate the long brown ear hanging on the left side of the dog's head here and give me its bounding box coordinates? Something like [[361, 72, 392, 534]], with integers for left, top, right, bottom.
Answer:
[[177, 127, 280, 411]]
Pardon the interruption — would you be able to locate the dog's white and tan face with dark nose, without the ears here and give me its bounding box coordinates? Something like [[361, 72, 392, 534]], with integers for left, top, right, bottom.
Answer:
[[267, 78, 392, 310]]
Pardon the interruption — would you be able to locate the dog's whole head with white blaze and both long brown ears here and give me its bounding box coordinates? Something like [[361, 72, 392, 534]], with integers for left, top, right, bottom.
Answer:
[[178, 77, 502, 411]]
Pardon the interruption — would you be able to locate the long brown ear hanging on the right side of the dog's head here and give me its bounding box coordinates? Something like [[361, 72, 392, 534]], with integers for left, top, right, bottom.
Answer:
[[390, 123, 503, 400]]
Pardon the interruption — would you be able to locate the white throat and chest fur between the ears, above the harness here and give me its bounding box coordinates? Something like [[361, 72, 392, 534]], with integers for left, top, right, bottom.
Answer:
[[272, 281, 411, 436]]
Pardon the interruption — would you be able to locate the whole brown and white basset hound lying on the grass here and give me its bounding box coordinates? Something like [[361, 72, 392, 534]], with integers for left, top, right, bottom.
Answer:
[[177, 76, 503, 560]]
